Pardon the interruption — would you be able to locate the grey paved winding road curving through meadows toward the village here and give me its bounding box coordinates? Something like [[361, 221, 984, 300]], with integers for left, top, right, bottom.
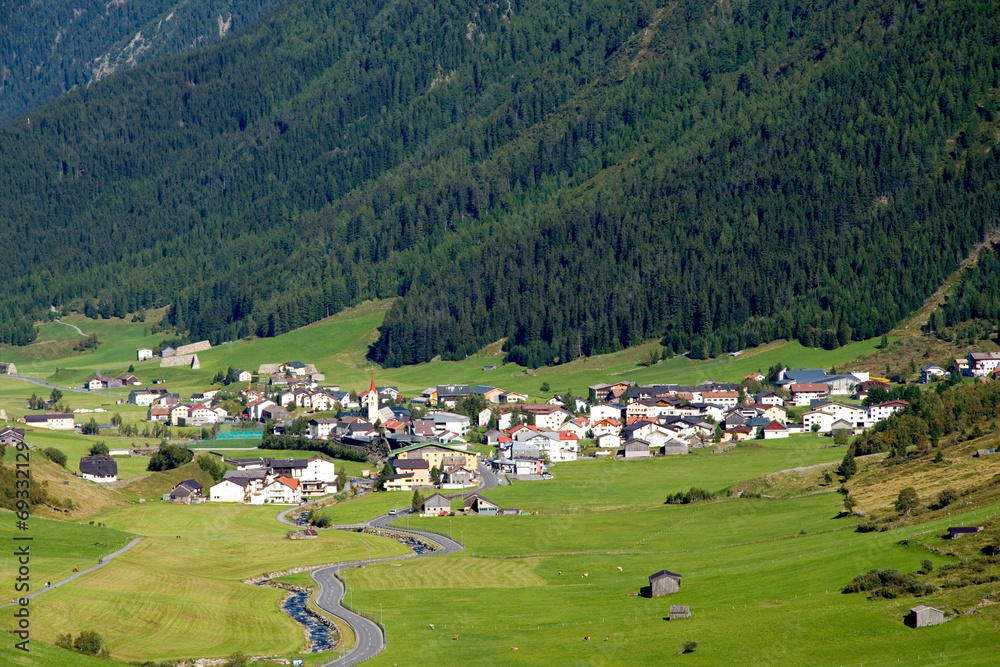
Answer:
[[292, 463, 499, 667]]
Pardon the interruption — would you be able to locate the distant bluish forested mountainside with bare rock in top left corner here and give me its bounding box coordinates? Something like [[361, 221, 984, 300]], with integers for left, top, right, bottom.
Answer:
[[0, 0, 281, 123]]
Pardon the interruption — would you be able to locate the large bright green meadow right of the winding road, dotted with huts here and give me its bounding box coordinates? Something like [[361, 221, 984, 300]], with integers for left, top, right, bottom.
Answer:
[[334, 449, 1000, 665]]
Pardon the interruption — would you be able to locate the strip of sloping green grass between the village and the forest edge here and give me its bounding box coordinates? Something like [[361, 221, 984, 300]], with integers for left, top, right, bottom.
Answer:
[[0, 301, 892, 402]]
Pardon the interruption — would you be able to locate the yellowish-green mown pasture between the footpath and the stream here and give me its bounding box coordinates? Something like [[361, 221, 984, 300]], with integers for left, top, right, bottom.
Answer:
[[25, 503, 406, 660]]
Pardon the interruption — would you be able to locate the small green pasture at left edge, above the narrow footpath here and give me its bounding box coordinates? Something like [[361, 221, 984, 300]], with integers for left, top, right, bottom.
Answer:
[[0, 510, 133, 602]]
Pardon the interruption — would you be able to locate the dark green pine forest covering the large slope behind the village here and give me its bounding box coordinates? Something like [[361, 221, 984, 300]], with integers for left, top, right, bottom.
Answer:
[[0, 0, 1000, 366]]
